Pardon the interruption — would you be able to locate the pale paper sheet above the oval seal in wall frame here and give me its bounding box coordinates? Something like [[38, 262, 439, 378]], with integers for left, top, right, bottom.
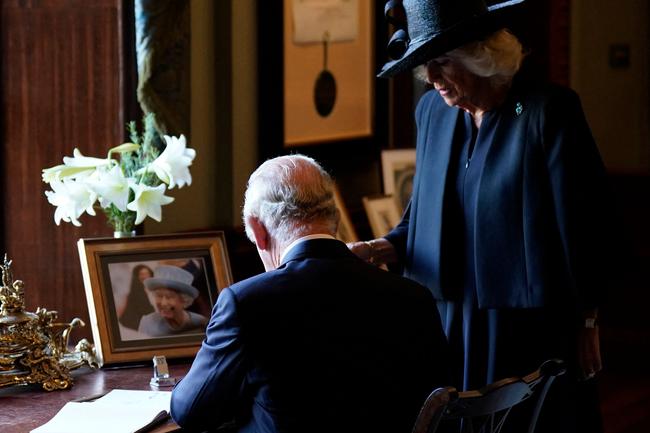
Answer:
[[293, 0, 359, 44]]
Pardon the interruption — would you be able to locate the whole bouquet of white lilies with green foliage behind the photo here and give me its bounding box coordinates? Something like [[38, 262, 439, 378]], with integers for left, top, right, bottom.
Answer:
[[41, 113, 196, 231]]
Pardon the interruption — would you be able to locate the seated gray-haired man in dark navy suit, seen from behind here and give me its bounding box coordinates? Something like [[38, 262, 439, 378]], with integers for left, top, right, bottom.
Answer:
[[171, 155, 448, 433]]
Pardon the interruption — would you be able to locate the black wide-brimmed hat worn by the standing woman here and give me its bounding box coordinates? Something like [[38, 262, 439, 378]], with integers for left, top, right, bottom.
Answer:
[[377, 0, 525, 78]]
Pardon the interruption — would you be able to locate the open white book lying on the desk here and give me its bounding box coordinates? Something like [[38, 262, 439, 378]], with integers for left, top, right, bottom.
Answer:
[[30, 389, 172, 433]]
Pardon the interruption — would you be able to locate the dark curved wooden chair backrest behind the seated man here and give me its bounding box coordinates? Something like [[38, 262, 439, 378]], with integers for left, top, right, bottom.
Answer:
[[413, 359, 566, 433]]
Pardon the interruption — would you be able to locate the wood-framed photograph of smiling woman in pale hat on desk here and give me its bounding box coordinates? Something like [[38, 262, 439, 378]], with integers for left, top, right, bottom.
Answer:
[[78, 232, 232, 364]]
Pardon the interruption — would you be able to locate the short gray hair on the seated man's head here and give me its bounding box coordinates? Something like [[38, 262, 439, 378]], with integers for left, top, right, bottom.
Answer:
[[243, 155, 339, 243]]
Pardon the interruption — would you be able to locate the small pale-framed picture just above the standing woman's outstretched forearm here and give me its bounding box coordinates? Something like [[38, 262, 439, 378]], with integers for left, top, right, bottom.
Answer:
[[381, 149, 415, 213]]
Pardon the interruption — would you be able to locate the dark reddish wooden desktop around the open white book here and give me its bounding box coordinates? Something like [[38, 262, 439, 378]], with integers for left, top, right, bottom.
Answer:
[[0, 363, 190, 433]]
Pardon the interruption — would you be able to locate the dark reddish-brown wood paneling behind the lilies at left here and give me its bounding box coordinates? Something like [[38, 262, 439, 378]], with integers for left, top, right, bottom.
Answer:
[[0, 0, 127, 340]]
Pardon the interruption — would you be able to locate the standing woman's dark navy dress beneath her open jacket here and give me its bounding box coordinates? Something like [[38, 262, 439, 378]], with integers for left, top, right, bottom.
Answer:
[[387, 82, 602, 433]]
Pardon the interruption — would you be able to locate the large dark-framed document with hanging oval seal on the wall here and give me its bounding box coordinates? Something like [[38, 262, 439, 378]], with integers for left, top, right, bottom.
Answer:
[[255, 0, 390, 177]]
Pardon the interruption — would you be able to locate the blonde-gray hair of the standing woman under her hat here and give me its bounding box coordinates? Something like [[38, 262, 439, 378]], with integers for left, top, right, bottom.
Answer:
[[415, 29, 525, 86]]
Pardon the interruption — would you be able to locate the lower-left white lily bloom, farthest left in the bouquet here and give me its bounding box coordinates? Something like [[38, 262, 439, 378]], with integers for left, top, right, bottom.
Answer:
[[45, 179, 97, 226]]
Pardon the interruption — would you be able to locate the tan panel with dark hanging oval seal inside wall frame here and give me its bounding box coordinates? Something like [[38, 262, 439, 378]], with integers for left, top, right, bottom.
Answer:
[[282, 0, 375, 147]]
